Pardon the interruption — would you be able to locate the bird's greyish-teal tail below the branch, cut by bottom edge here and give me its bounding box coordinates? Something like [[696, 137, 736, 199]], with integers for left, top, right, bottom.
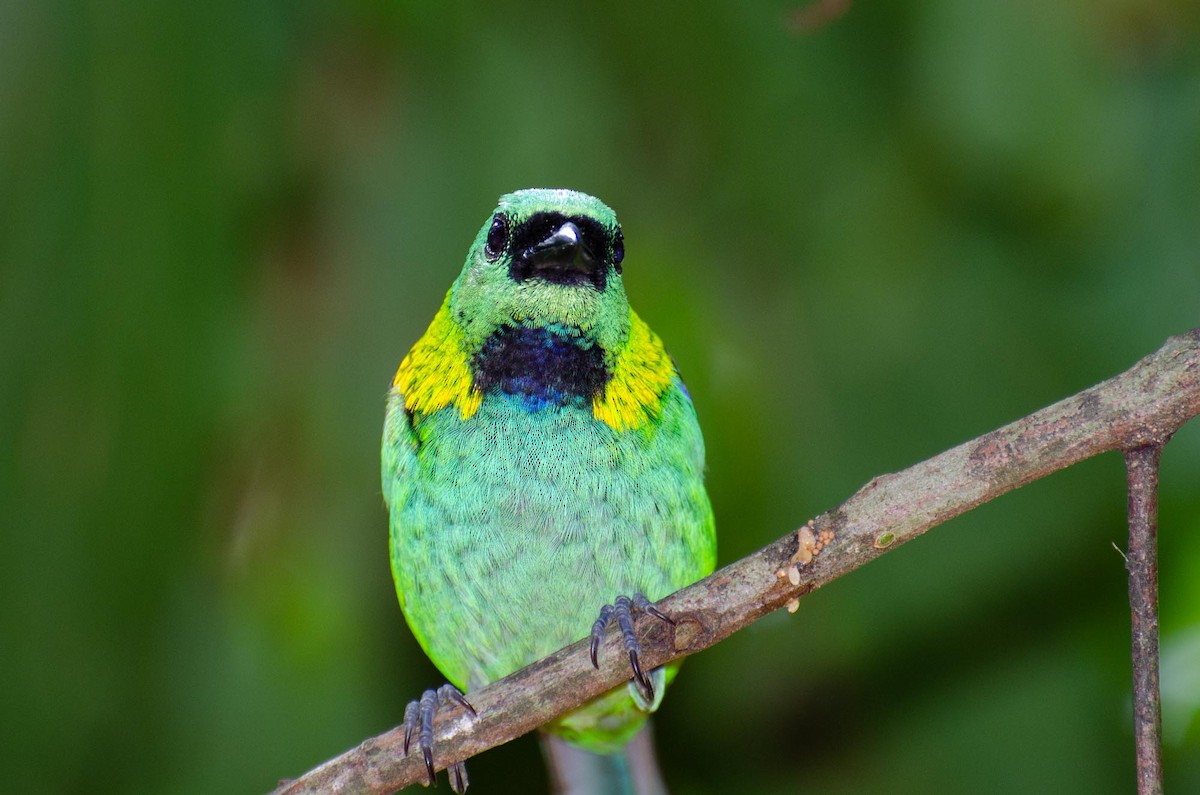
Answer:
[[541, 721, 667, 795]]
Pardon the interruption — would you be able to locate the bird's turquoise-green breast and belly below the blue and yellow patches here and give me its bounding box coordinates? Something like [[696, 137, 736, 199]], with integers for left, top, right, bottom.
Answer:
[[383, 381, 715, 688]]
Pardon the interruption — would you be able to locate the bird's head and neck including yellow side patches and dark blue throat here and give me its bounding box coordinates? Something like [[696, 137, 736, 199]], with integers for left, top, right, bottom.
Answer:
[[392, 190, 677, 431]]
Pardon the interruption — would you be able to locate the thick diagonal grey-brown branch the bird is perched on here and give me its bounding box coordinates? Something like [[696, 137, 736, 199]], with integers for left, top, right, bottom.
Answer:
[[275, 329, 1200, 795]]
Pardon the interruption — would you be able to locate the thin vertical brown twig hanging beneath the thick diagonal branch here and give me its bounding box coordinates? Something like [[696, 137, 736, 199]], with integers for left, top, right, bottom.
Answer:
[[1126, 444, 1163, 795]]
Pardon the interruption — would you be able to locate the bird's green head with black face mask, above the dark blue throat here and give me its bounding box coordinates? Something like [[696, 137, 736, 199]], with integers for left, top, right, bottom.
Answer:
[[449, 189, 630, 351]]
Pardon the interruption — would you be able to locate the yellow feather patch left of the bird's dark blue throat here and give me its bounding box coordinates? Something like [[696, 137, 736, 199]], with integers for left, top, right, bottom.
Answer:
[[391, 302, 484, 419]]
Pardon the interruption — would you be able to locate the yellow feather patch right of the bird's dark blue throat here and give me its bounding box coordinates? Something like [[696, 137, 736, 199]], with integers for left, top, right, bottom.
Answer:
[[592, 310, 674, 431]]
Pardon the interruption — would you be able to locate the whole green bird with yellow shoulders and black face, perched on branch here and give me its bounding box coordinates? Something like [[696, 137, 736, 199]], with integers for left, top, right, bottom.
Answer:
[[382, 189, 716, 791]]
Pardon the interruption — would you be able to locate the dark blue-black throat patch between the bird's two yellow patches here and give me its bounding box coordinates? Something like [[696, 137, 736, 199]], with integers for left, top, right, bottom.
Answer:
[[470, 325, 610, 411]]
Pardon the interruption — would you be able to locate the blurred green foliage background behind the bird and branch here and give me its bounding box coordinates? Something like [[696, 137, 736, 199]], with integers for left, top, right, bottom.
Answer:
[[0, 0, 1200, 794]]
